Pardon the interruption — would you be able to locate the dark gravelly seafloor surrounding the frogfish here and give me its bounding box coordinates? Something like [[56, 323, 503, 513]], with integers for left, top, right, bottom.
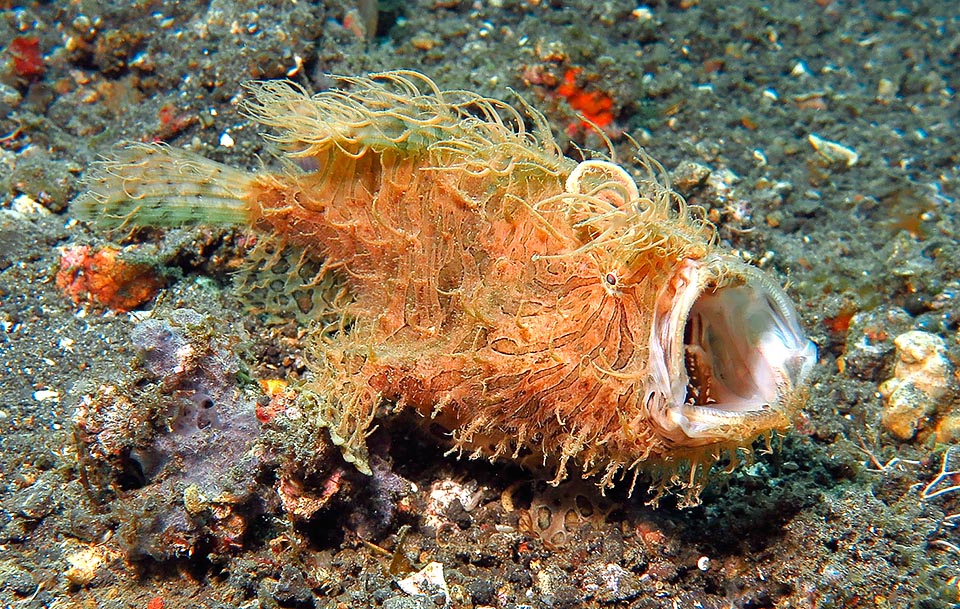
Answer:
[[0, 0, 960, 609]]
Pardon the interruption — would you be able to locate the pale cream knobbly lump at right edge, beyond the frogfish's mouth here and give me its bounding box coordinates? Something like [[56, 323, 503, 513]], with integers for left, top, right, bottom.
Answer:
[[880, 330, 960, 442]]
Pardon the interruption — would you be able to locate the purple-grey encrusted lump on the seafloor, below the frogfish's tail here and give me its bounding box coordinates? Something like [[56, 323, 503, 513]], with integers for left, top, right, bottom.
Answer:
[[74, 309, 269, 559]]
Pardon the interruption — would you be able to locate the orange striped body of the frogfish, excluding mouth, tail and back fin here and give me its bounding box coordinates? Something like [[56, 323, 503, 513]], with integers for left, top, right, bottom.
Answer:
[[237, 124, 710, 494]]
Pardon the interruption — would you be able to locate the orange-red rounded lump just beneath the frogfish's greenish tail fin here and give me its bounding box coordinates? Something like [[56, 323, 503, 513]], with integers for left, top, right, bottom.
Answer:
[[56, 245, 163, 312]]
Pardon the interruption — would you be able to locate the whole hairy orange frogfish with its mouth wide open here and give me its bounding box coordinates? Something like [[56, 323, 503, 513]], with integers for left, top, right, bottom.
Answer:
[[75, 71, 816, 504]]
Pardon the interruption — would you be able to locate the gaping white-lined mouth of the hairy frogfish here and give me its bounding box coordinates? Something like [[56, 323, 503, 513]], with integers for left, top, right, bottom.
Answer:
[[647, 254, 817, 447]]
